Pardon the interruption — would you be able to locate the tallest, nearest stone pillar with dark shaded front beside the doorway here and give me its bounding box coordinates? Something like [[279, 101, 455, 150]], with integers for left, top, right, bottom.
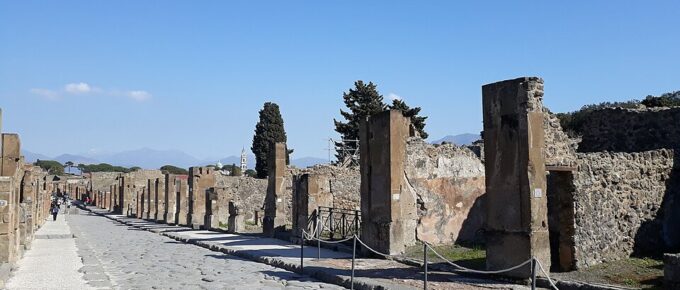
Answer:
[[482, 77, 550, 278]]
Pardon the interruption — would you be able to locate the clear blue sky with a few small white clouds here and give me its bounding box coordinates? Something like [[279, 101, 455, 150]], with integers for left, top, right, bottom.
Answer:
[[0, 1, 680, 158]]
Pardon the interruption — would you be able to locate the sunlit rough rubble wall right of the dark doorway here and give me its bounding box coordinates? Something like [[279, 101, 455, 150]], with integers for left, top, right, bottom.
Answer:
[[573, 149, 674, 267]]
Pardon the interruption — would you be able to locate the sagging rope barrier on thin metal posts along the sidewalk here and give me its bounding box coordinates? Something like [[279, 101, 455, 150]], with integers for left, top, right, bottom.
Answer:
[[300, 230, 559, 290]]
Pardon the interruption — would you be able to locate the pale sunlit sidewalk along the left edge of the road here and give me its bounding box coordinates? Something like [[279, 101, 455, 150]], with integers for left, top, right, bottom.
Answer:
[[5, 206, 94, 289]]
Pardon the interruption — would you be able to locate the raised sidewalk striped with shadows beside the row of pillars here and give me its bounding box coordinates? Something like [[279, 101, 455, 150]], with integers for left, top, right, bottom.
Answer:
[[88, 207, 529, 289]]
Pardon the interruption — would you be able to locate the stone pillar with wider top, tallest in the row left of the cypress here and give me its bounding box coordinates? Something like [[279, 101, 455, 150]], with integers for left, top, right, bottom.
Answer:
[[189, 167, 215, 229]]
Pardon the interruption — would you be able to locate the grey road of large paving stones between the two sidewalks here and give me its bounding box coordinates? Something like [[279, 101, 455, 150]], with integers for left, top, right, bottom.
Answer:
[[67, 212, 343, 289]]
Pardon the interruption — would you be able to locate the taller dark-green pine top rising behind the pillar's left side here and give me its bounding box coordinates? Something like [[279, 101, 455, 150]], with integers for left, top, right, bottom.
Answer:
[[333, 80, 387, 160]]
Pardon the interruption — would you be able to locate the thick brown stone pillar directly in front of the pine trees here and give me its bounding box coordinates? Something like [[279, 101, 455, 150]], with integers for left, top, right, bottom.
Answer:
[[359, 110, 417, 254]]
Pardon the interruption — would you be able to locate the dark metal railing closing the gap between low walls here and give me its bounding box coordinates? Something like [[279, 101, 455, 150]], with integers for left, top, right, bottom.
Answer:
[[318, 206, 361, 240]]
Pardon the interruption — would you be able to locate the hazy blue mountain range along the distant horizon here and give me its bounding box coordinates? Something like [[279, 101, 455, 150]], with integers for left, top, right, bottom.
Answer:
[[22, 148, 328, 169]]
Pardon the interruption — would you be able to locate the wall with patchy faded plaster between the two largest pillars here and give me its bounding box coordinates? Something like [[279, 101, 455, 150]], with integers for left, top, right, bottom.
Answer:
[[404, 137, 485, 244]]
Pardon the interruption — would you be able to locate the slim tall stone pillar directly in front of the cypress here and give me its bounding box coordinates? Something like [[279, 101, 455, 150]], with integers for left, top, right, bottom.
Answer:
[[262, 142, 286, 237]]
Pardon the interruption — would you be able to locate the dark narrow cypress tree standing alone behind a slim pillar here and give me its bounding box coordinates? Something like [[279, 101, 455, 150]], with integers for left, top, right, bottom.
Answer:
[[250, 102, 292, 178]]
